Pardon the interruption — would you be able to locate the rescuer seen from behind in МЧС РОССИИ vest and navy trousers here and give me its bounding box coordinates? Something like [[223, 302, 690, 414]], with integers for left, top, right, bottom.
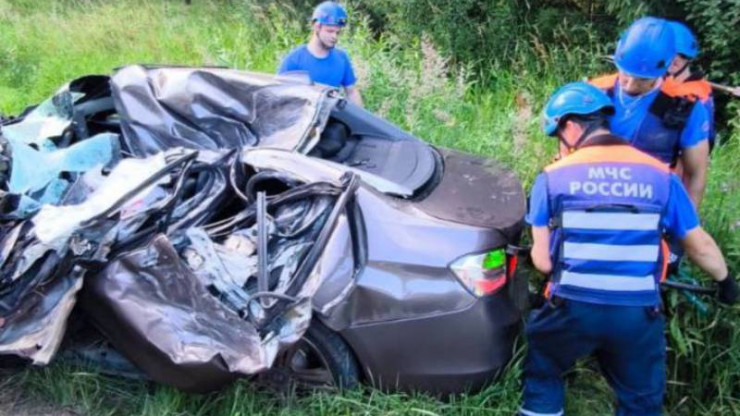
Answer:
[[519, 82, 738, 416]]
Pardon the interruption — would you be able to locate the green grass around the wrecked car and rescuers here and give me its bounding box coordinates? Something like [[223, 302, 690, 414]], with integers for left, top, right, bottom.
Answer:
[[0, 0, 740, 416]]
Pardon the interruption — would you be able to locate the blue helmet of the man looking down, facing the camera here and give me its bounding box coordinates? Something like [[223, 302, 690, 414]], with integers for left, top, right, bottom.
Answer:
[[614, 17, 676, 78]]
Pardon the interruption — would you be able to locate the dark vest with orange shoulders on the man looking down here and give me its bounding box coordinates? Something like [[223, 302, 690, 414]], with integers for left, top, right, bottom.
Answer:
[[590, 74, 697, 167]]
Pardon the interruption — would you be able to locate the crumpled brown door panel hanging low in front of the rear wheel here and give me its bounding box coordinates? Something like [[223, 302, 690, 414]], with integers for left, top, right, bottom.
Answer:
[[83, 235, 279, 391]]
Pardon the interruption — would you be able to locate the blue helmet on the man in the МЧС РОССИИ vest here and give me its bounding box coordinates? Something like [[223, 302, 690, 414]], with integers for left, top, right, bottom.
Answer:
[[542, 82, 614, 136]]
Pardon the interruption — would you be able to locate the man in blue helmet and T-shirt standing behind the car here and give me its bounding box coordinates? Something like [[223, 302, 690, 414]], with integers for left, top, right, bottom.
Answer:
[[278, 1, 362, 106]]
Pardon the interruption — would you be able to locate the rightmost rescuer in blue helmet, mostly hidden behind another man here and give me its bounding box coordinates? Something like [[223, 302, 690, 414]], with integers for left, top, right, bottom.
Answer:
[[666, 22, 717, 149]]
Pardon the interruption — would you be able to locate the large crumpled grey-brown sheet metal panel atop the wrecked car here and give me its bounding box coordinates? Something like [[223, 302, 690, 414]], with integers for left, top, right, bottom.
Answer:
[[111, 66, 338, 156]]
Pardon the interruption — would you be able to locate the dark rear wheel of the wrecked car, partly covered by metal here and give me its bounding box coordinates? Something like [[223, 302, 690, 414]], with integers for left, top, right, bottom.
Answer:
[[260, 321, 360, 392]]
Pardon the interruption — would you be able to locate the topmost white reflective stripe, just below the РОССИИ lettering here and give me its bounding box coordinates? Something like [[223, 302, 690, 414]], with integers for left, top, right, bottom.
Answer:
[[563, 211, 660, 230]]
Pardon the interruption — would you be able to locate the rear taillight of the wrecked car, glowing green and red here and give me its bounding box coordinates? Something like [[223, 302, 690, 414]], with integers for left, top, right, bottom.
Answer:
[[450, 249, 508, 297]]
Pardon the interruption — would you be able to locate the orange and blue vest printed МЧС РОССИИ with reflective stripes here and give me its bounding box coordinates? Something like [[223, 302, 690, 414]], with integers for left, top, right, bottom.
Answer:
[[545, 136, 670, 306]]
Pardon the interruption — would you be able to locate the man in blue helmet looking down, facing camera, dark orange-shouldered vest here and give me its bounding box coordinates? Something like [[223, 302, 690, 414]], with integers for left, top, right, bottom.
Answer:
[[591, 17, 711, 208]]
